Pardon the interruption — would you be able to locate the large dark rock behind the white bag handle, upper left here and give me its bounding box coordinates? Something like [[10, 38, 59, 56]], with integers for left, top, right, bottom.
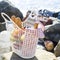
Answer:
[[0, 1, 23, 32]]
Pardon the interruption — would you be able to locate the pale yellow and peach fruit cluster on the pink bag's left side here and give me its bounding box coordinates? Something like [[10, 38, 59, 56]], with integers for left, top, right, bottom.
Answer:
[[10, 28, 25, 41]]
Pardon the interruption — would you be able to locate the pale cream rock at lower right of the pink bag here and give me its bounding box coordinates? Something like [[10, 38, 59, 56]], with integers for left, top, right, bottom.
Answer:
[[36, 49, 57, 60]]
